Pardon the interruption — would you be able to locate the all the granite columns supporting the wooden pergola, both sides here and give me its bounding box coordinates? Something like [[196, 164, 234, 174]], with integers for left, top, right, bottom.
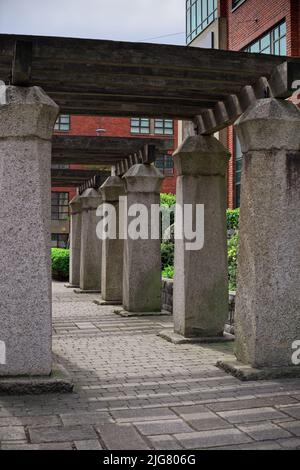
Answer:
[[0, 87, 300, 376]]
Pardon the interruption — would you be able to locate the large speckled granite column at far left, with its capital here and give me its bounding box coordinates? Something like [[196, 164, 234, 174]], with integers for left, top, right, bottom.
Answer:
[[0, 86, 59, 376]]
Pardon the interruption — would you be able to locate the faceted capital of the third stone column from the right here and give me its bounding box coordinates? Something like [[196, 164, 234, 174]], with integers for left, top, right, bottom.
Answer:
[[123, 163, 164, 194]]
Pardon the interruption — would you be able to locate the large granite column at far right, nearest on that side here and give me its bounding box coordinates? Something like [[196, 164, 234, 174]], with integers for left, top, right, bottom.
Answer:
[[235, 99, 300, 368]]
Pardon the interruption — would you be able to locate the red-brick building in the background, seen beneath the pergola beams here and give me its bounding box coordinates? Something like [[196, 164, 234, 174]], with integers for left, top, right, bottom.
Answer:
[[51, 115, 178, 248]]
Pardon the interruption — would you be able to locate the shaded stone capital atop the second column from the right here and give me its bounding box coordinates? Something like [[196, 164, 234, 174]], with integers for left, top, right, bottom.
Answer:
[[173, 135, 230, 176]]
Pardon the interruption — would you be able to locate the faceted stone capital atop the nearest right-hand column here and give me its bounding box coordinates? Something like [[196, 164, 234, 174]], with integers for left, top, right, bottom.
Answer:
[[235, 98, 300, 153]]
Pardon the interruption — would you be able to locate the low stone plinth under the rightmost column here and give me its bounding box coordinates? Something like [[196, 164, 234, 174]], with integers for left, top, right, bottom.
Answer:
[[216, 360, 300, 382]]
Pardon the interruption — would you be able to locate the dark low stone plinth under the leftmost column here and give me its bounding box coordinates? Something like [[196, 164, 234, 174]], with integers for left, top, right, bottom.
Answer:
[[0, 364, 74, 396]]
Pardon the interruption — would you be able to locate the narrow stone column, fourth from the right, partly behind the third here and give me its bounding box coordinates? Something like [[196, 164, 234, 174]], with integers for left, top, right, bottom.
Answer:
[[100, 176, 125, 304]]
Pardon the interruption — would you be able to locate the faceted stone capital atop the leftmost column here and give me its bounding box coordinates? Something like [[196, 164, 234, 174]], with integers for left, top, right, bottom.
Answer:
[[0, 86, 59, 140]]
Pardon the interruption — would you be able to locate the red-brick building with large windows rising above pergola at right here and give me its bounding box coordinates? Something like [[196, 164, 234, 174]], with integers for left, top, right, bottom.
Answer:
[[186, 0, 300, 208]]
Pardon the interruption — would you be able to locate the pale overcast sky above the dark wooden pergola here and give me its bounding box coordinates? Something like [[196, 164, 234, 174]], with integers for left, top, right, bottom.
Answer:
[[0, 0, 185, 44]]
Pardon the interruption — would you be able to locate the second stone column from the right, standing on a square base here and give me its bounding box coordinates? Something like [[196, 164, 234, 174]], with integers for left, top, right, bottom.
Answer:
[[173, 136, 229, 337]]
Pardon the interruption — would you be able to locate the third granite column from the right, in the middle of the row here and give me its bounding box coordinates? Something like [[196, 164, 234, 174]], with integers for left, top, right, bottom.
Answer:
[[123, 164, 163, 312]]
